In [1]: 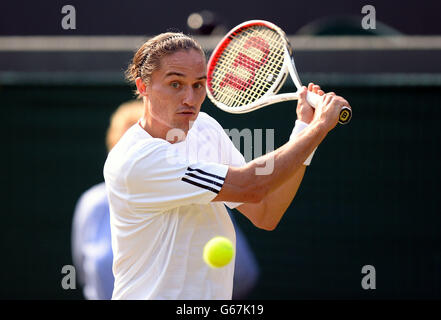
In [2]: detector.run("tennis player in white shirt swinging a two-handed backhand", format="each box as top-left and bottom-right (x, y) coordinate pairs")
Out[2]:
(104, 33), (349, 299)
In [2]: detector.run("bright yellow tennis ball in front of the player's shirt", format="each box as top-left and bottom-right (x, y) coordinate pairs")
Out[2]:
(203, 236), (234, 268)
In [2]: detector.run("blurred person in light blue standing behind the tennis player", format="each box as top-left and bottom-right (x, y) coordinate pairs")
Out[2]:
(72, 100), (259, 300)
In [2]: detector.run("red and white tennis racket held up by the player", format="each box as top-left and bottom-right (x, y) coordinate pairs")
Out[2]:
(207, 20), (352, 124)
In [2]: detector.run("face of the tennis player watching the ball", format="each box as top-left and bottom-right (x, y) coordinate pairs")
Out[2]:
(146, 49), (206, 139)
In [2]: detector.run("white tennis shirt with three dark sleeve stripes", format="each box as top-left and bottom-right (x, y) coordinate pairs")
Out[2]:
(104, 112), (245, 299)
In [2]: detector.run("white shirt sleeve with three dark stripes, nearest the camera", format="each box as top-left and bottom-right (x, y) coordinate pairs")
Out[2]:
(126, 142), (228, 212)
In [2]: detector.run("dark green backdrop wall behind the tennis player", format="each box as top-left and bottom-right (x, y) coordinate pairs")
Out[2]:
(0, 81), (441, 299)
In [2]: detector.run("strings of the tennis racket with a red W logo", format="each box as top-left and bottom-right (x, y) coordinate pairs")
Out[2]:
(211, 26), (284, 107)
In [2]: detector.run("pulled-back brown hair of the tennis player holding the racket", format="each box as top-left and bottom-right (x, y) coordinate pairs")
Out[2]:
(125, 32), (205, 95)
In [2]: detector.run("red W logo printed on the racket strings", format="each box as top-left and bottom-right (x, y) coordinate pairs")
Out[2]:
(219, 37), (269, 90)
